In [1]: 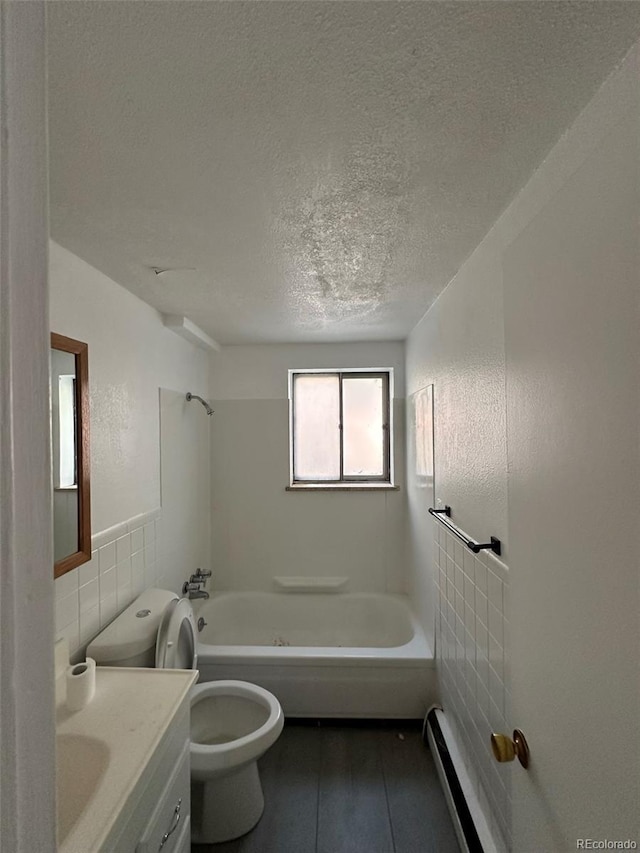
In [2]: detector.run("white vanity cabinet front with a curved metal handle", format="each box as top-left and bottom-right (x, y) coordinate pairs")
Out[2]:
(136, 743), (191, 853)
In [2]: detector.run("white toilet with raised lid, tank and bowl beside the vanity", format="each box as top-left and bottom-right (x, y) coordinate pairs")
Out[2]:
(87, 589), (284, 844)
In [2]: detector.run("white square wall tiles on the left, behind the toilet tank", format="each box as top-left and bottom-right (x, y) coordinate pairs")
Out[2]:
(55, 510), (161, 658)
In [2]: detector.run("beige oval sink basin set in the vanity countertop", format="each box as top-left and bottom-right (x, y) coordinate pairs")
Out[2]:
(56, 734), (109, 844)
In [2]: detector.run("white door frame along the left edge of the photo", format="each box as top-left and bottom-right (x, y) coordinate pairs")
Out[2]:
(0, 0), (55, 853)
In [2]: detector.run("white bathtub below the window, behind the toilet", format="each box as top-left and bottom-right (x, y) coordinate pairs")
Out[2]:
(193, 592), (435, 718)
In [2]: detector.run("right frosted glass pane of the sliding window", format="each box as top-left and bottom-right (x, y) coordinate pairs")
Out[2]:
(342, 376), (384, 477)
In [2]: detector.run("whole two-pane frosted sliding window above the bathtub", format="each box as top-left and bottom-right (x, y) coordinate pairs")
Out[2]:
(289, 370), (393, 487)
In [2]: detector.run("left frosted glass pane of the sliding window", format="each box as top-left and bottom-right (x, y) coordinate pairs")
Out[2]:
(293, 374), (340, 481)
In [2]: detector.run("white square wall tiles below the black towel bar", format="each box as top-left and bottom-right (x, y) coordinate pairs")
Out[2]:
(434, 521), (511, 850)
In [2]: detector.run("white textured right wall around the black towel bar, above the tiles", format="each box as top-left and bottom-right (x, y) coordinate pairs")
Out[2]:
(406, 236), (508, 648)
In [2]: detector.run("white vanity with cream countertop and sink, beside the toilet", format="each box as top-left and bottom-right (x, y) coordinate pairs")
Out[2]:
(56, 650), (197, 853)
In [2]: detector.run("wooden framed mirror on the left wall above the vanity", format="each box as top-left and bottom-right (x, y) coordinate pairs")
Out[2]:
(50, 333), (91, 578)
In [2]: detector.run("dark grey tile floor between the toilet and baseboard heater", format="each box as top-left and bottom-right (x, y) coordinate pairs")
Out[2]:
(192, 722), (458, 853)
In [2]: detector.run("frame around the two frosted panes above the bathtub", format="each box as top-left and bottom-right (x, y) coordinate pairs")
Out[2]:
(288, 367), (395, 489)
